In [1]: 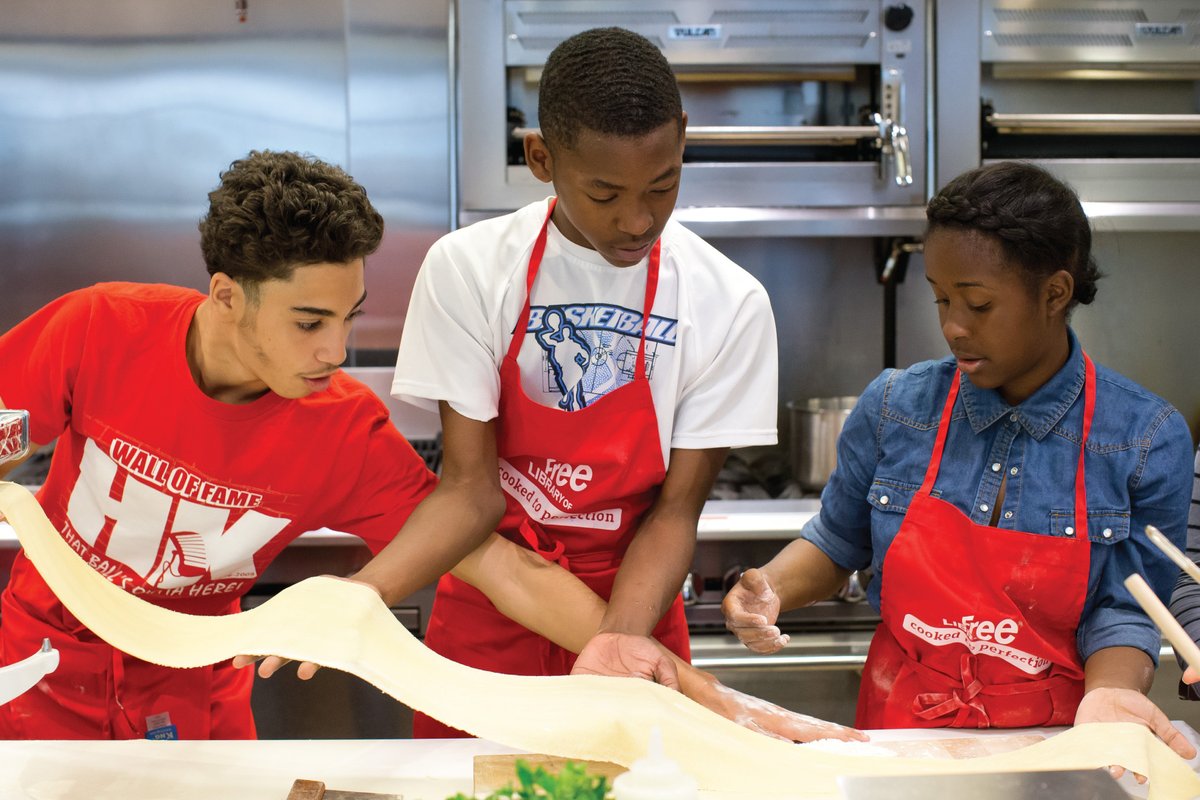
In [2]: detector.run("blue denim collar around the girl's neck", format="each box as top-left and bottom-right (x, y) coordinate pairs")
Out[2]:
(959, 327), (1085, 441)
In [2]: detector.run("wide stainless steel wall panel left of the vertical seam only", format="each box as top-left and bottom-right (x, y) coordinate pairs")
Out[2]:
(0, 0), (347, 330)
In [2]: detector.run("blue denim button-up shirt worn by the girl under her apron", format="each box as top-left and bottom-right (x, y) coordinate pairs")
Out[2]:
(800, 331), (1192, 664)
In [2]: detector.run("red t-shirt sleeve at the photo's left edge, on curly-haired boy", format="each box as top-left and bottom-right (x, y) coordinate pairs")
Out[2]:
(0, 289), (95, 445)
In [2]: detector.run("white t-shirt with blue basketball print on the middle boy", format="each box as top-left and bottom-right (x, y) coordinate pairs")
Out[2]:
(391, 200), (779, 462)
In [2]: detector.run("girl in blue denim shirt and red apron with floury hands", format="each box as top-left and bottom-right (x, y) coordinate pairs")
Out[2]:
(725, 162), (1195, 758)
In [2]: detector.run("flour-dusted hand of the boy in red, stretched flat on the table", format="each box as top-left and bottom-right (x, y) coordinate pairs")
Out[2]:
(684, 668), (868, 741)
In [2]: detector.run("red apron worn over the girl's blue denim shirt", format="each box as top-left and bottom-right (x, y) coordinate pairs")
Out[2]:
(854, 354), (1096, 729)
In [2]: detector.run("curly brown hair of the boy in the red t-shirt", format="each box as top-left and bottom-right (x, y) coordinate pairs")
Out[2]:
(199, 150), (383, 299)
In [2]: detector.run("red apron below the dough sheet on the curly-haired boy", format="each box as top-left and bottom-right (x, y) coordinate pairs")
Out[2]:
(0, 553), (254, 739)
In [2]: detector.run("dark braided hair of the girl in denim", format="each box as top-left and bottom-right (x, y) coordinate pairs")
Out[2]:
(925, 161), (1103, 309)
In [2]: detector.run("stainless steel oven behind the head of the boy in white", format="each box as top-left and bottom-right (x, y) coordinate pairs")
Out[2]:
(457, 0), (929, 235)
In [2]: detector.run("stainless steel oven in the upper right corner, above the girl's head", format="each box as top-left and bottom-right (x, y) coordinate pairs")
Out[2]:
(937, 0), (1200, 229)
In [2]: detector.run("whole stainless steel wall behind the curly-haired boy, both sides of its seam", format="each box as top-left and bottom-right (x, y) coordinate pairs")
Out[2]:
(0, 0), (450, 350)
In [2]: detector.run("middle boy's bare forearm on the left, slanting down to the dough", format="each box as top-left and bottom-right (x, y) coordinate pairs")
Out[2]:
(353, 481), (504, 604)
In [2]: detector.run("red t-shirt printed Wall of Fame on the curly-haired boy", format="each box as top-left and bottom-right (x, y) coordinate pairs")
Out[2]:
(0, 283), (436, 614)
